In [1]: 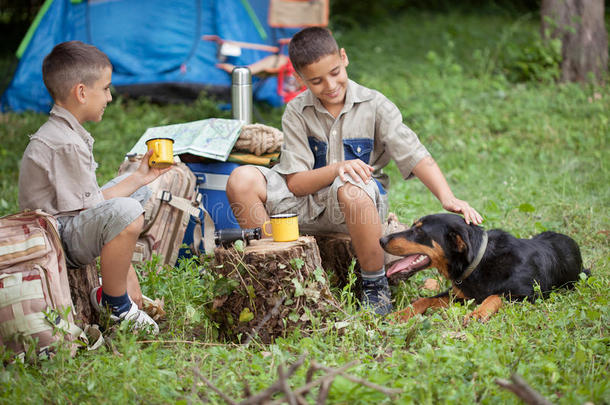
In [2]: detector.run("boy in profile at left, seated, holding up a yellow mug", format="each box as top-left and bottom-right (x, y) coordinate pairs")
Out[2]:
(19, 41), (169, 333)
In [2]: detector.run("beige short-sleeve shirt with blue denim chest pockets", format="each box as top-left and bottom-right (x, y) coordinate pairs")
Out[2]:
(273, 80), (430, 188)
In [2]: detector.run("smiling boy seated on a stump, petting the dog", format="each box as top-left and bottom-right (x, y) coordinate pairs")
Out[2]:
(227, 27), (482, 315)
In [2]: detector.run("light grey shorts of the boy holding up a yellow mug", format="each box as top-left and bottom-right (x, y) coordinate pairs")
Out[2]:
(57, 173), (151, 268)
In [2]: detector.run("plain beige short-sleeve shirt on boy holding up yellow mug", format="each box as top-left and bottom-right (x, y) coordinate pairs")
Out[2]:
(19, 105), (104, 216)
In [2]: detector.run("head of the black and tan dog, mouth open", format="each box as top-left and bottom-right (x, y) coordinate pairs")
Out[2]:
(379, 214), (480, 280)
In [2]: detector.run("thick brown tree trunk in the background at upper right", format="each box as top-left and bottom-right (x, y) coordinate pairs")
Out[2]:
(540, 0), (608, 84)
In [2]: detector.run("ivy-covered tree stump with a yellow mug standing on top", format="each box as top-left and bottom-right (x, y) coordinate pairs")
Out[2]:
(210, 236), (339, 343)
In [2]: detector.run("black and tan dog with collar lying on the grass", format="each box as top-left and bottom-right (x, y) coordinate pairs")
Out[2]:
(380, 214), (589, 323)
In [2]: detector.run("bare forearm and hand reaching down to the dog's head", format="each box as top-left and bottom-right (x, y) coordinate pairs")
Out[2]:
(413, 156), (483, 225)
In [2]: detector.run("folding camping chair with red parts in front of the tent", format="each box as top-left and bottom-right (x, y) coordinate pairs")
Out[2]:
(202, 0), (329, 103)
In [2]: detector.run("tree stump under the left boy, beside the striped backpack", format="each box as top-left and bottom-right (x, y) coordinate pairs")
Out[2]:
(68, 262), (100, 325)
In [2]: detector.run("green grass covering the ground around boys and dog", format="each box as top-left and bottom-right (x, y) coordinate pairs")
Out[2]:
(0, 13), (610, 404)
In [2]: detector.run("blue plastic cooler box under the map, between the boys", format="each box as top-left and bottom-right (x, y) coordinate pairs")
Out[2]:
(180, 162), (239, 256)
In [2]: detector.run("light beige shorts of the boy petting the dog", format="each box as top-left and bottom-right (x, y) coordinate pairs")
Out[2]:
(255, 166), (388, 234)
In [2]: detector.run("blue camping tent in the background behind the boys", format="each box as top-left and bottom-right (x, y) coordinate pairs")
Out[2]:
(1, 0), (295, 112)
